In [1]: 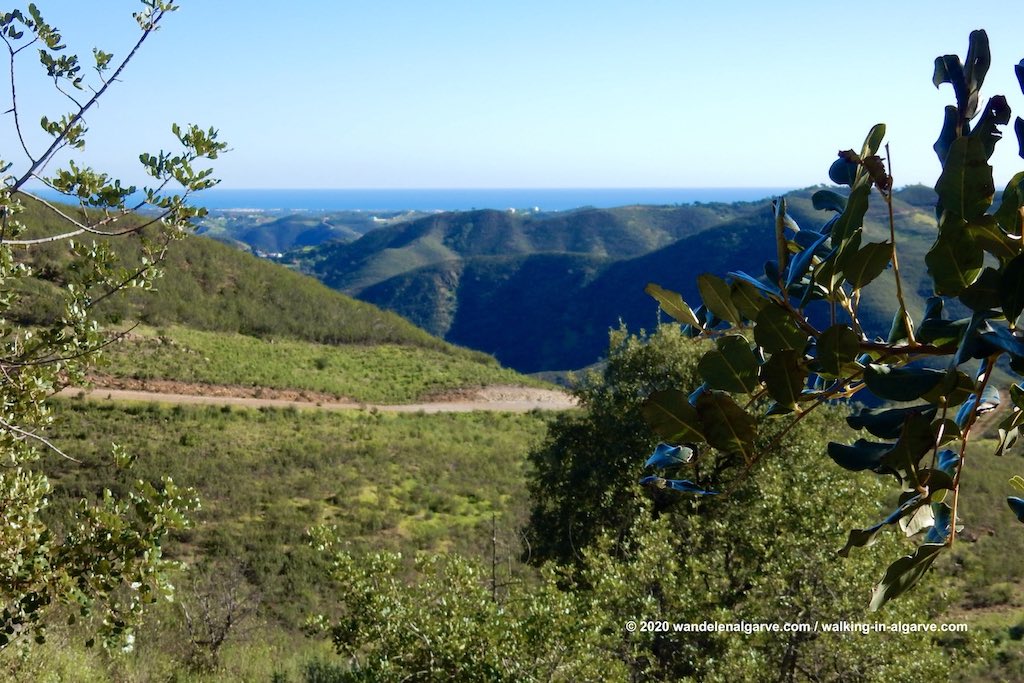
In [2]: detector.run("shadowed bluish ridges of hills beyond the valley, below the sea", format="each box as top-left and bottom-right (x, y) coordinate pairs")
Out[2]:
(284, 186), (935, 372)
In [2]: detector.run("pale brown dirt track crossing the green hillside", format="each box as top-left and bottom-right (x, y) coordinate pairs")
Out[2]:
(57, 385), (577, 413)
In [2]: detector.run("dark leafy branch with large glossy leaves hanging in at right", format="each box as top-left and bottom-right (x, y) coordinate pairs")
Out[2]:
(643, 31), (1024, 609)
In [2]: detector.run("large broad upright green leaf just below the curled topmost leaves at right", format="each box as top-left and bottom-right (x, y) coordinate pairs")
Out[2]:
(935, 137), (995, 219)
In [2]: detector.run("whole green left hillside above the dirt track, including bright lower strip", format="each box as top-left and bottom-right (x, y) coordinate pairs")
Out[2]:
(13, 193), (552, 403)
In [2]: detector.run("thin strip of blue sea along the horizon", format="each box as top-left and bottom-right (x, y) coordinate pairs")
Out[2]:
(169, 187), (791, 211)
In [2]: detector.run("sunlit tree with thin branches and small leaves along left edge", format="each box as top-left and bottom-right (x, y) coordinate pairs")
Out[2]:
(0, 0), (224, 648)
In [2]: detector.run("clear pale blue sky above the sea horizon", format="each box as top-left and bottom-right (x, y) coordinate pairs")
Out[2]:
(0, 0), (1024, 188)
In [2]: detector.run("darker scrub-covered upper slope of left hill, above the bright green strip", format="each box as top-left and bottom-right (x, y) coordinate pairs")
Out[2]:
(16, 192), (467, 354)
